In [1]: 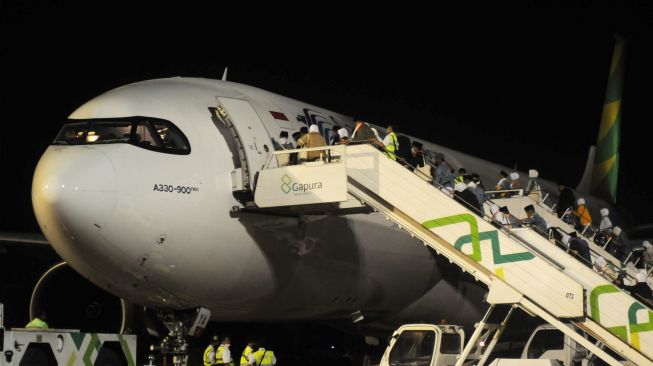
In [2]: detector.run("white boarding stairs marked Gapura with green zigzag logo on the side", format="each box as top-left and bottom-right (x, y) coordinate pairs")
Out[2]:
(255, 145), (653, 366)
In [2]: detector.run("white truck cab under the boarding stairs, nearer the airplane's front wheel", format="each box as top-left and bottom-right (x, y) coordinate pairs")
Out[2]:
(380, 324), (465, 366)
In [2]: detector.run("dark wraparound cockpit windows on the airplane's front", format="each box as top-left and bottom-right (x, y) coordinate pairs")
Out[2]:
(53, 117), (190, 154)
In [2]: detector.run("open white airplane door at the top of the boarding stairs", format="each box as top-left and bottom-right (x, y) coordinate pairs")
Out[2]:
(217, 97), (274, 190)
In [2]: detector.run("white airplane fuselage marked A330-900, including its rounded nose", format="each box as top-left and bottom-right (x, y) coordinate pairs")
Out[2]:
(32, 78), (483, 321)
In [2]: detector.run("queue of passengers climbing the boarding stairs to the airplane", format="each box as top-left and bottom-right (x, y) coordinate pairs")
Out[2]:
(268, 121), (653, 302)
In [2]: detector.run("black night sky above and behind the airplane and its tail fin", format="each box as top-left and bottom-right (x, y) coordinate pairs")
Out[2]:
(0, 1), (653, 231)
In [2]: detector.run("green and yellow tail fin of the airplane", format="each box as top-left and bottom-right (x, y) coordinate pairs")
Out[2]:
(579, 36), (625, 203)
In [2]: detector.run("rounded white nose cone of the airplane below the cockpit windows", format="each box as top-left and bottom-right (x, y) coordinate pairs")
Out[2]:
(32, 146), (118, 244)
